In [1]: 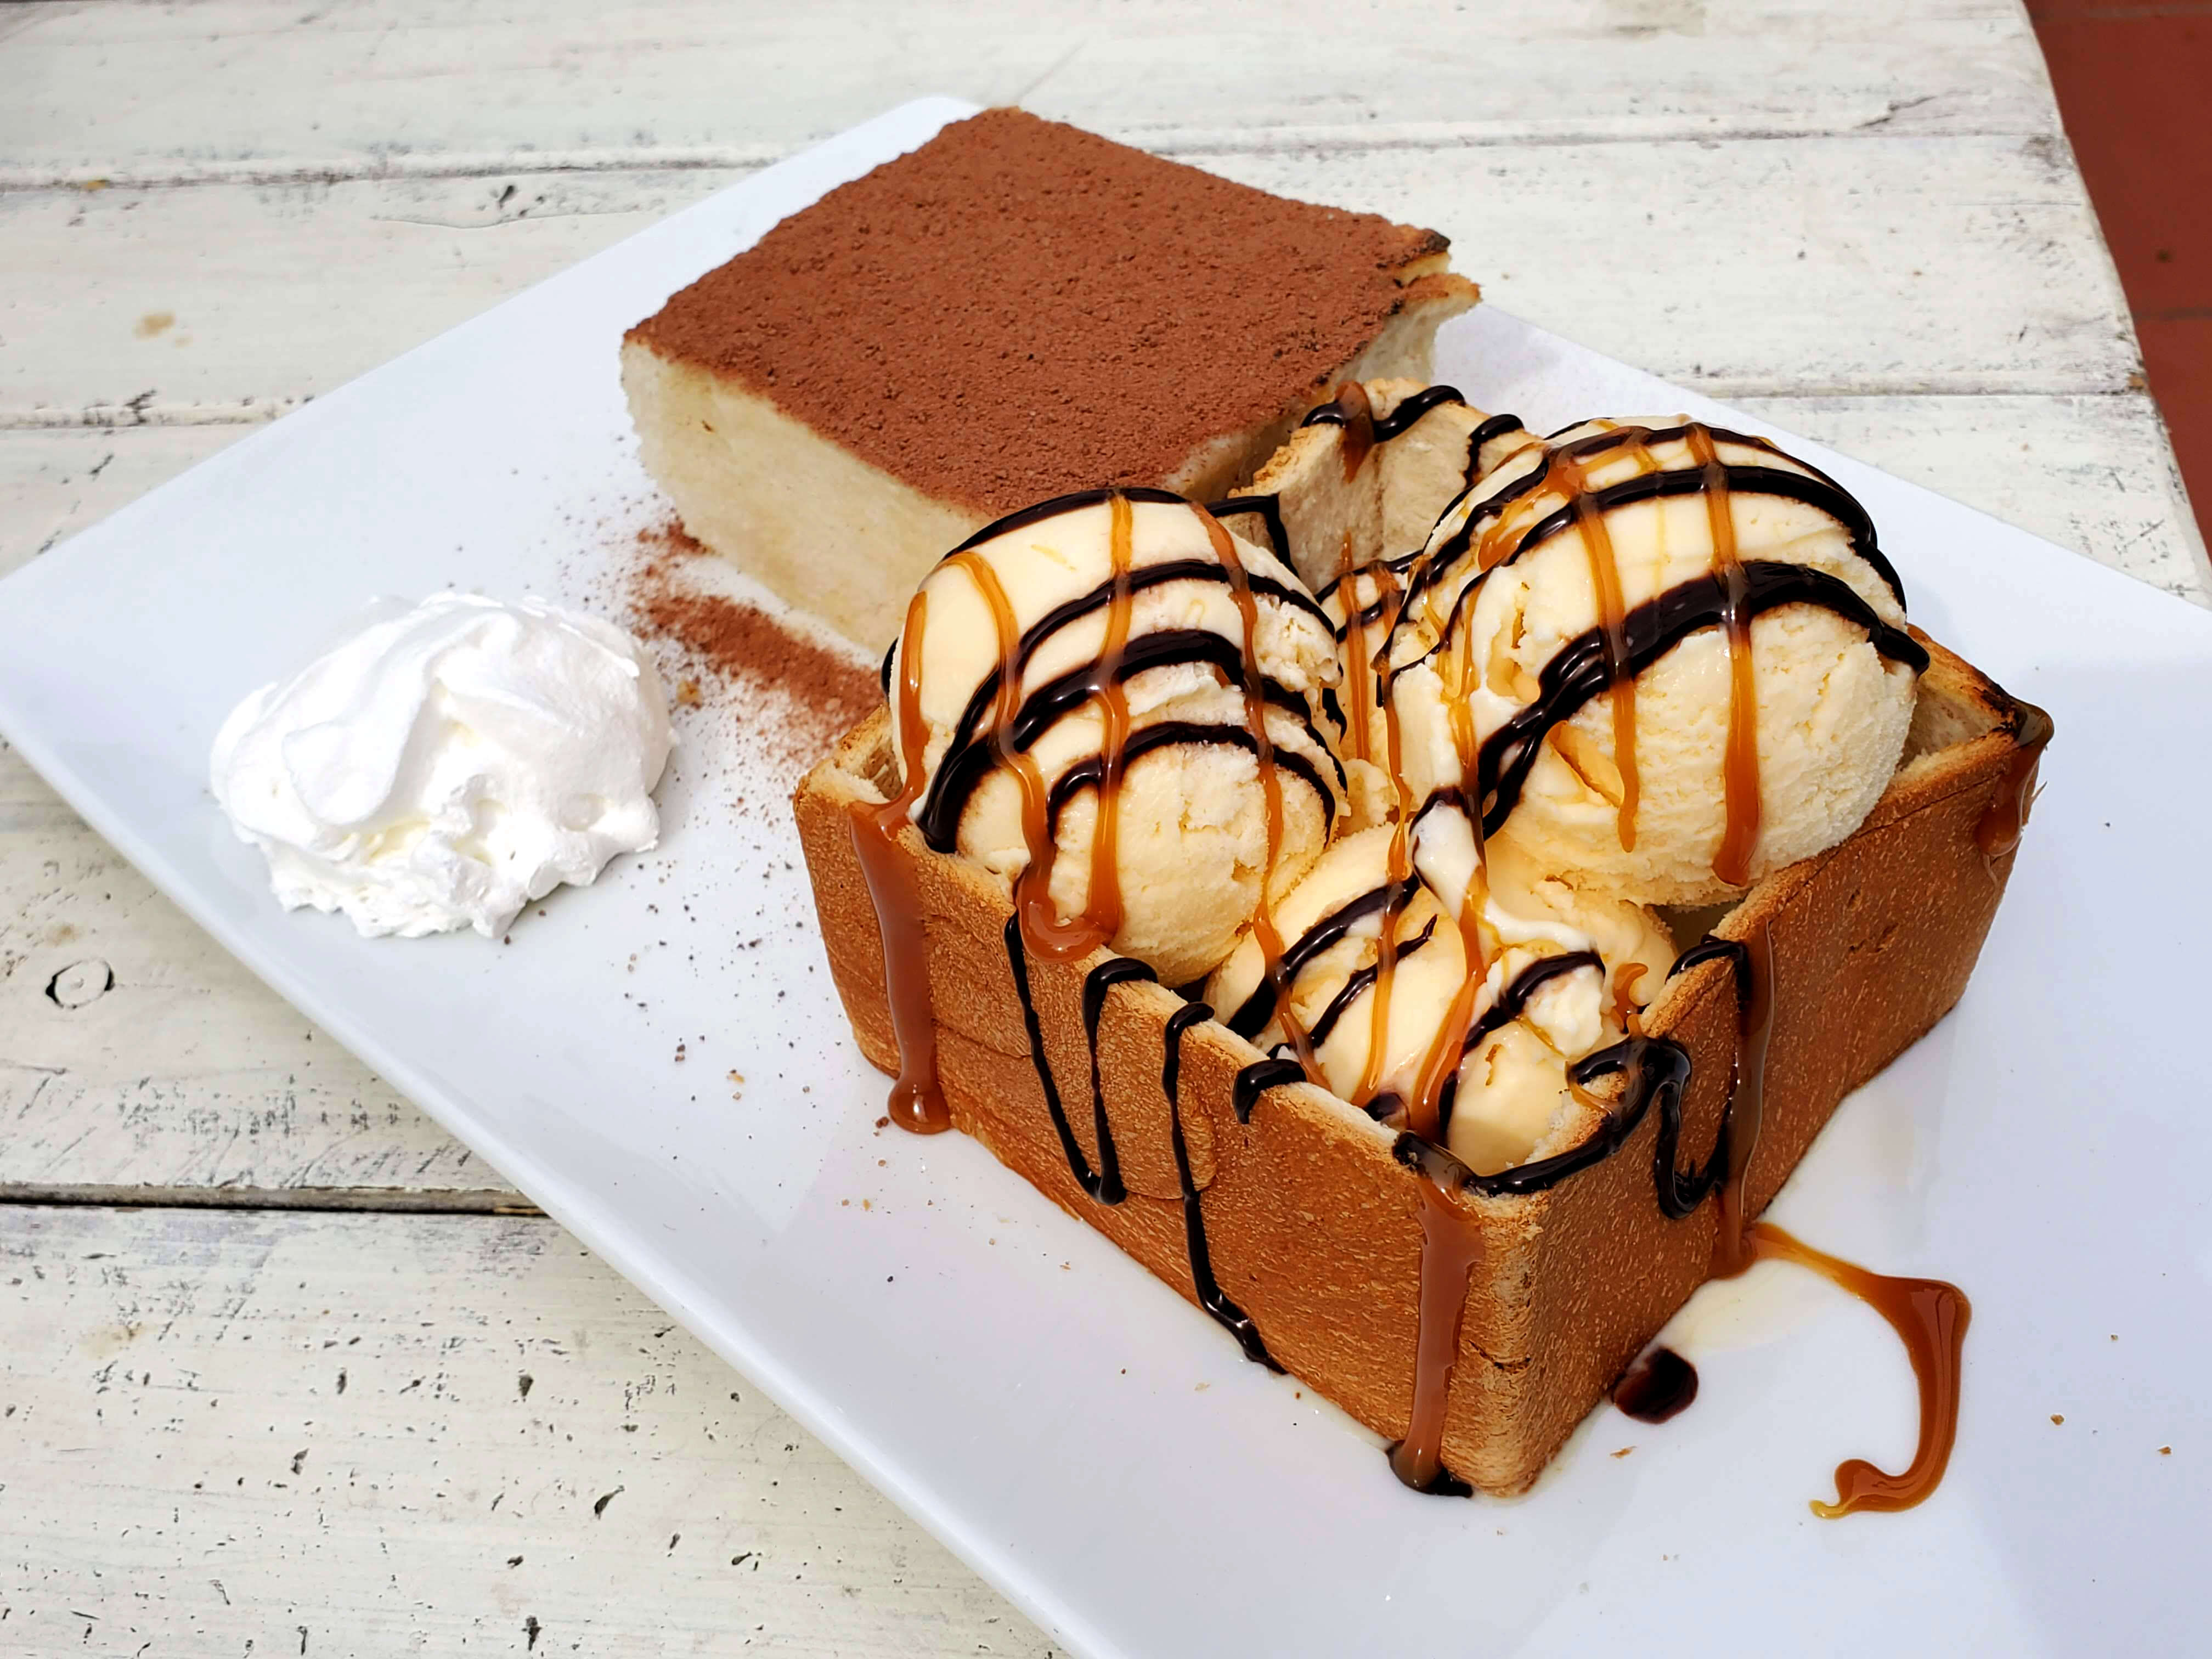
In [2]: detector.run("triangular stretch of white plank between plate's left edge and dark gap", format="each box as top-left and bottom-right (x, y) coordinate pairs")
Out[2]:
(0, 746), (527, 1207)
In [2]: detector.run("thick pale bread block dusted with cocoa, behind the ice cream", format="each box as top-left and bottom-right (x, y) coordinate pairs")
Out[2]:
(622, 109), (1475, 650)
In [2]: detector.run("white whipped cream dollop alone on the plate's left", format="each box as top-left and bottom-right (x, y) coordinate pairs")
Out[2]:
(210, 593), (673, 938)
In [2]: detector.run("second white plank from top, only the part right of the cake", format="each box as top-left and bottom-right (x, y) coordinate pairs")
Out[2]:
(1194, 137), (2141, 398)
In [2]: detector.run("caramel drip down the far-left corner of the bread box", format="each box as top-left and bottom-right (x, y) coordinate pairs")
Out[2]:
(851, 593), (953, 1135)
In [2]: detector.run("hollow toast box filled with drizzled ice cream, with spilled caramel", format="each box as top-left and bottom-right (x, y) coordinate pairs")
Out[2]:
(797, 381), (2049, 1513)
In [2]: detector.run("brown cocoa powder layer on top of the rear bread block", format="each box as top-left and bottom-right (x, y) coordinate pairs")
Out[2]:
(630, 109), (1447, 515)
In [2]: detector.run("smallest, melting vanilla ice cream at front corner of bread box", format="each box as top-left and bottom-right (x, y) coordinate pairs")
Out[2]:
(1205, 825), (1674, 1175)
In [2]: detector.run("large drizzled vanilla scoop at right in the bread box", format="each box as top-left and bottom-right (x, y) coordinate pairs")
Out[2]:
(1376, 418), (1927, 905)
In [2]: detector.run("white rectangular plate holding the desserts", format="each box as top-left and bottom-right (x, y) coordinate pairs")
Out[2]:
(0, 99), (2212, 1657)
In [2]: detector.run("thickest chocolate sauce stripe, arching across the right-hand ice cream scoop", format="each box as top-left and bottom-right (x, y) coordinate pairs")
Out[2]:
(1460, 562), (1929, 836)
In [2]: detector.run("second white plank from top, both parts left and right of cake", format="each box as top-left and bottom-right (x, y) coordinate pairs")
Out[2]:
(0, 137), (2139, 427)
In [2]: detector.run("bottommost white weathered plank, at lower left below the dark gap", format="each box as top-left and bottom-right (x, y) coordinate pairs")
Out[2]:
(0, 1205), (1053, 1659)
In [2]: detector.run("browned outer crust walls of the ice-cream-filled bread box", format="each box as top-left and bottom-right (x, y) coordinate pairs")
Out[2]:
(794, 630), (2026, 1493)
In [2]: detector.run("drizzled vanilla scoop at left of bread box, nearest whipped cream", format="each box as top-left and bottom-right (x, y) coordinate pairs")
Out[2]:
(887, 489), (1345, 984)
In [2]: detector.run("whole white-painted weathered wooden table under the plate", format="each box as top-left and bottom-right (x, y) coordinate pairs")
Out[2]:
(0, 0), (2212, 1655)
